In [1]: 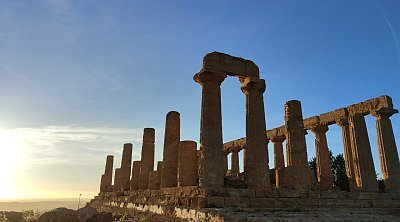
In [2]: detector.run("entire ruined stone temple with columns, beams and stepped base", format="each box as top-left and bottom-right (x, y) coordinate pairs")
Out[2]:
(90, 52), (400, 221)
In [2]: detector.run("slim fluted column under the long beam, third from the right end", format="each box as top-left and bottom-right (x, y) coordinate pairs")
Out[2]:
(336, 118), (357, 191)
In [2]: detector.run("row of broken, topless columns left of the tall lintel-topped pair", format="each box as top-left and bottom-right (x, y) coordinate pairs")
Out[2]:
(100, 111), (198, 192)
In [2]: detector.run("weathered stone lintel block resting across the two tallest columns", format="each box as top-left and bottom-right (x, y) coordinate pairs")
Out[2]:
(201, 52), (259, 78)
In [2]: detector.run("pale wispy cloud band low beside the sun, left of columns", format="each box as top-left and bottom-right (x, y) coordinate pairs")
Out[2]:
(0, 126), (142, 166)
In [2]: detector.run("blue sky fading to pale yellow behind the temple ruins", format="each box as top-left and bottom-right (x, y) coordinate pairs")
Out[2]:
(0, 0), (400, 200)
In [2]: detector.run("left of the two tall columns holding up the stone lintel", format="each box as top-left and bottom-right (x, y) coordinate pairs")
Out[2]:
(194, 71), (228, 187)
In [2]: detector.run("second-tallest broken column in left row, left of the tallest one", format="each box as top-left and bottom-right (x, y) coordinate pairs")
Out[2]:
(139, 128), (155, 190)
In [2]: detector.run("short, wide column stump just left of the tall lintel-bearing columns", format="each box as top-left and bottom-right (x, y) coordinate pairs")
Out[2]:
(178, 141), (198, 187)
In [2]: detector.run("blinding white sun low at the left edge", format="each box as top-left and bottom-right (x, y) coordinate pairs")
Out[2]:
(0, 129), (22, 199)
